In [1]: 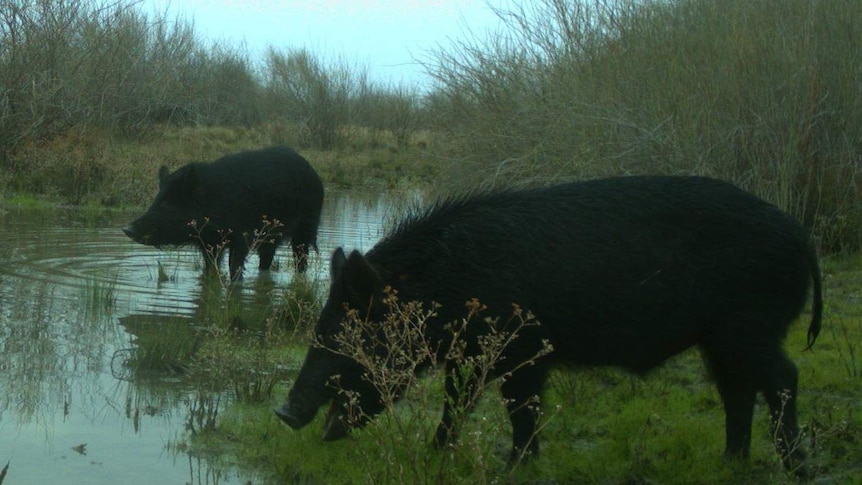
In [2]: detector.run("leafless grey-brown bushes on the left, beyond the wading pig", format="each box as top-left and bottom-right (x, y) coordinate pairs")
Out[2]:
(0, 0), (416, 153)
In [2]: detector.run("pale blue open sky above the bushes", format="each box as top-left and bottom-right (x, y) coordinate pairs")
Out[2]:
(145, 0), (508, 85)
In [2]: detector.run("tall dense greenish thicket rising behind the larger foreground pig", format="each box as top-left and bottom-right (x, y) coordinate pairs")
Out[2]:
(427, 0), (862, 250)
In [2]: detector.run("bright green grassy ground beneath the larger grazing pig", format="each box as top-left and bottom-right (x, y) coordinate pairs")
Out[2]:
(182, 257), (862, 484)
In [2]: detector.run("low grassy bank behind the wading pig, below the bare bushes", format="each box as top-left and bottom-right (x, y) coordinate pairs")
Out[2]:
(0, 125), (440, 207)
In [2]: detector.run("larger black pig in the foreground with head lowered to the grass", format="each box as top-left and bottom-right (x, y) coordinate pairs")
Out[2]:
(276, 176), (823, 469)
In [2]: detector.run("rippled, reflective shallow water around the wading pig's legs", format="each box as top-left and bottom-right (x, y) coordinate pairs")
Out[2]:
(0, 190), (412, 485)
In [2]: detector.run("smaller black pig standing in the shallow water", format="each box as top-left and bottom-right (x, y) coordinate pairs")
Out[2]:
(123, 147), (323, 279)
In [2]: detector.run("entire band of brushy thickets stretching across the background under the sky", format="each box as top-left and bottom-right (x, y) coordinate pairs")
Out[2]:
(0, 0), (862, 250)
